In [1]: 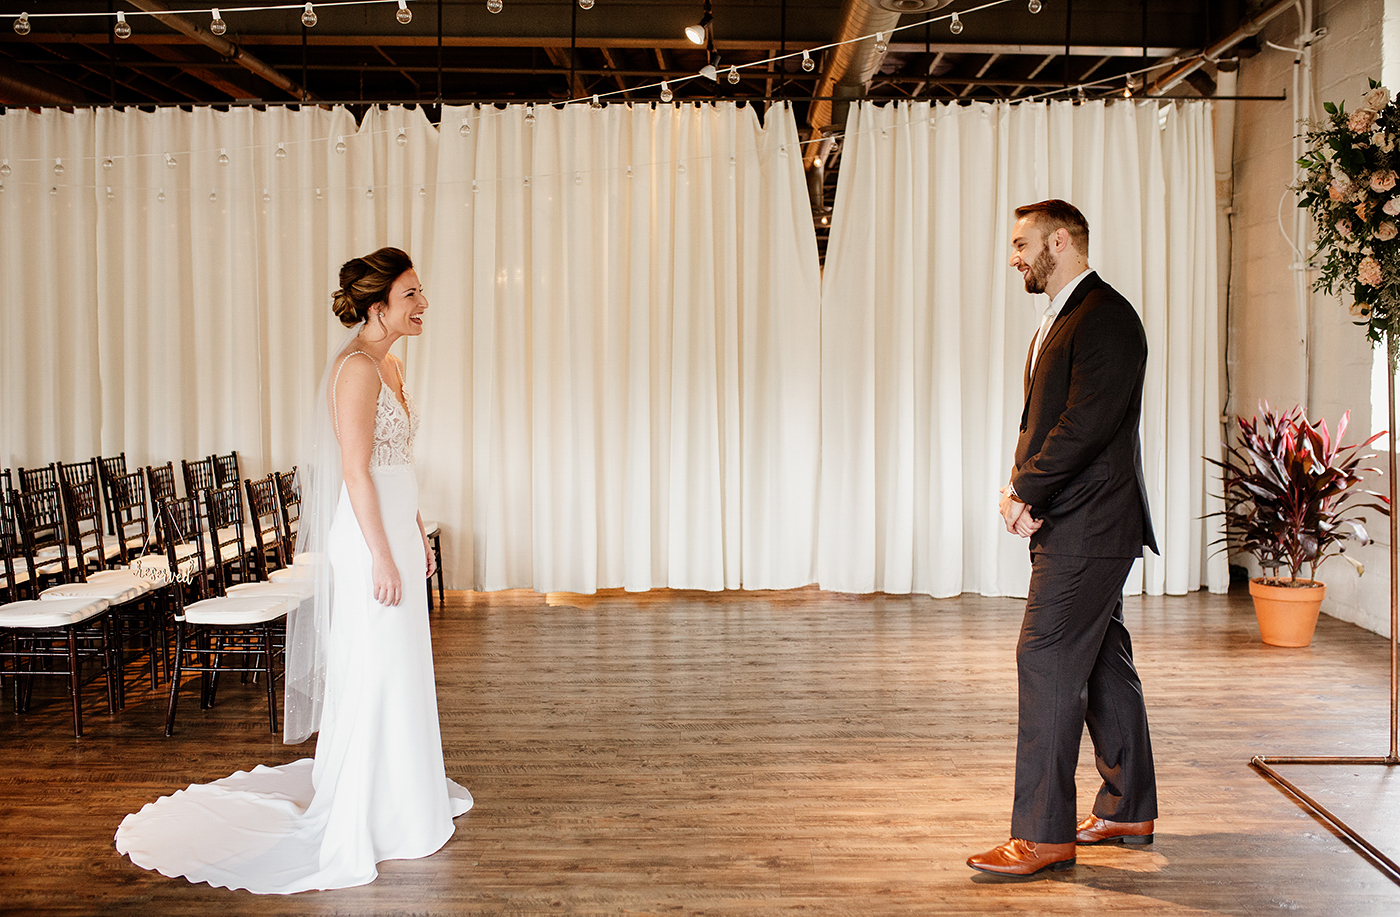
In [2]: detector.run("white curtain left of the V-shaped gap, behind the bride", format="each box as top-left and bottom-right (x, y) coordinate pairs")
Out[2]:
(0, 105), (820, 591)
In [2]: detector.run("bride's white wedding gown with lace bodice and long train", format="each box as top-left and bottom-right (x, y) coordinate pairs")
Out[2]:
(116, 361), (472, 895)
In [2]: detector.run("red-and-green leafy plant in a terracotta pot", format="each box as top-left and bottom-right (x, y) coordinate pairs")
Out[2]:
(1207, 403), (1390, 647)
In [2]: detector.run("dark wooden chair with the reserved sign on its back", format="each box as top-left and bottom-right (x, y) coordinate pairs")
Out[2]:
(164, 497), (288, 735)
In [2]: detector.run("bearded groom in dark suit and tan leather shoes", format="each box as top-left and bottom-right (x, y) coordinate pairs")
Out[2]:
(967, 200), (1156, 875)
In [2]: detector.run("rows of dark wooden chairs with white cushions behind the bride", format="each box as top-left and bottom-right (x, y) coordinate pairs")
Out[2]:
(0, 454), (305, 735)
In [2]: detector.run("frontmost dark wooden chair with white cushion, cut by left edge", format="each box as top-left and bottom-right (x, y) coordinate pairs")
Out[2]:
(0, 480), (119, 738)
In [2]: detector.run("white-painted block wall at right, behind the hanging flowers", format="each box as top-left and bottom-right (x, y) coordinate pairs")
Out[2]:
(1226, 0), (1400, 634)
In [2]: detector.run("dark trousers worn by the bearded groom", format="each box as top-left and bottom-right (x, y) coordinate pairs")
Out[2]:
(1011, 552), (1156, 844)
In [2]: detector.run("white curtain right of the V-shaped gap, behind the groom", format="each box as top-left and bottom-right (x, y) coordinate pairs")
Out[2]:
(818, 102), (1228, 596)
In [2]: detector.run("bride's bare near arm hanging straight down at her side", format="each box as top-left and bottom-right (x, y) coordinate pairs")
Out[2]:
(335, 356), (403, 605)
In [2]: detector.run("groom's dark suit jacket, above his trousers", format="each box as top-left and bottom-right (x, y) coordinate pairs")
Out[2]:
(1011, 273), (1159, 557)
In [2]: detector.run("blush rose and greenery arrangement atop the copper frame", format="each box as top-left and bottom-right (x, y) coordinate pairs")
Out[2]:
(1292, 80), (1400, 343)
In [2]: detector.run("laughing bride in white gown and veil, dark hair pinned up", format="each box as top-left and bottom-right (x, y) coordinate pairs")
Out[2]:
(116, 248), (472, 895)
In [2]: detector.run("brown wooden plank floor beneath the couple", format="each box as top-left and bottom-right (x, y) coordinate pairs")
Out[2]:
(0, 589), (1400, 917)
